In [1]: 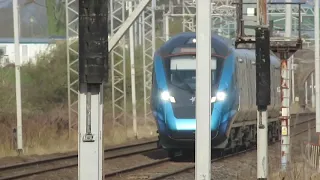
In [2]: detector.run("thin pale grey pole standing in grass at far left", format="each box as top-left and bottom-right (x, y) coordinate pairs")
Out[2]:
(13, 0), (23, 154)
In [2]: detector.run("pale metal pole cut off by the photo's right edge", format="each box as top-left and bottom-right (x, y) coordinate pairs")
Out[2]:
(314, 1), (320, 133)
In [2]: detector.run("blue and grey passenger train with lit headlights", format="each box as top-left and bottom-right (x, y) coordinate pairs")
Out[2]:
(151, 32), (281, 156)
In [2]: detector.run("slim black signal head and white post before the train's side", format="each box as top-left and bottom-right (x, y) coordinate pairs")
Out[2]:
(256, 27), (271, 179)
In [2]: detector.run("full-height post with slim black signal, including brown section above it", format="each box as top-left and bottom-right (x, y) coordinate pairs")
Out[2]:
(256, 0), (271, 180)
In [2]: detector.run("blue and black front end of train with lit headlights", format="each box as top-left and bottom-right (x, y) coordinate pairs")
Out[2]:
(151, 37), (232, 150)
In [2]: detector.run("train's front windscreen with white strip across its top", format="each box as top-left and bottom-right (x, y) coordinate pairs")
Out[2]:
(169, 56), (217, 91)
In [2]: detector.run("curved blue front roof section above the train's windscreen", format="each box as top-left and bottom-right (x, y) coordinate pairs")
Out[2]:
(156, 32), (232, 57)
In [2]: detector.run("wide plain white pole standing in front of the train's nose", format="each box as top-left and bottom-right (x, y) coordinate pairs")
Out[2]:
(195, 1), (211, 180)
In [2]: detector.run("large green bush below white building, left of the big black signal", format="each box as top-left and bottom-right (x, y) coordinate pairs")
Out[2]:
(0, 45), (68, 114)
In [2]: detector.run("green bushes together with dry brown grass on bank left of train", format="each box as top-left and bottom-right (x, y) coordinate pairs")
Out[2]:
(0, 17), (182, 157)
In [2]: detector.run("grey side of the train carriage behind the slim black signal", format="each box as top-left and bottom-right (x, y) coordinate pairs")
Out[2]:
(229, 49), (281, 122)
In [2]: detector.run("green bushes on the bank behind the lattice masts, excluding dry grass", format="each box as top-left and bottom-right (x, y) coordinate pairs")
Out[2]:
(0, 18), (182, 115)
